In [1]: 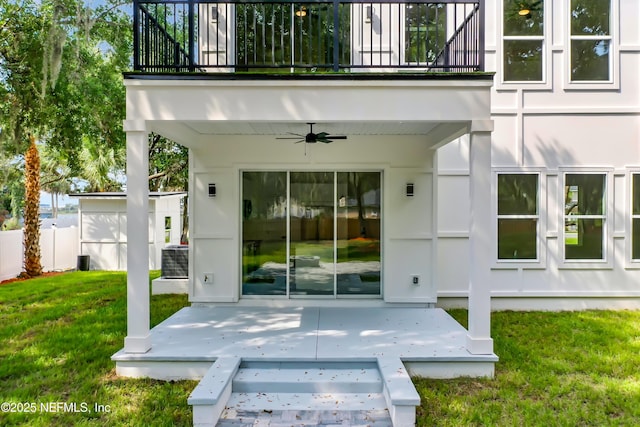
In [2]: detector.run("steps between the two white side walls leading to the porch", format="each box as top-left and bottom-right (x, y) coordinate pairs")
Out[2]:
(217, 361), (392, 427)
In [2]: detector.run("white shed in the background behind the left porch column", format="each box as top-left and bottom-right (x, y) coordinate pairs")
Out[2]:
(70, 192), (186, 271)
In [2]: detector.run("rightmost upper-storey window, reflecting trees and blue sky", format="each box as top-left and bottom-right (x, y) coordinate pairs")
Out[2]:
(570, 0), (612, 82)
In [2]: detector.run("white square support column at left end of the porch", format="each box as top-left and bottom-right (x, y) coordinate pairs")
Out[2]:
(124, 120), (151, 353)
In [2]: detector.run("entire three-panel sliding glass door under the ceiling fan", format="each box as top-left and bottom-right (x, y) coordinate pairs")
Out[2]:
(242, 171), (382, 298)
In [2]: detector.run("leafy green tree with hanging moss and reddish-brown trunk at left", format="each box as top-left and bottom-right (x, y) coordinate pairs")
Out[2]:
(0, 0), (130, 275)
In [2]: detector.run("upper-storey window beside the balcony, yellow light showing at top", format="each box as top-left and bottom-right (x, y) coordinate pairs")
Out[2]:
(502, 0), (544, 82)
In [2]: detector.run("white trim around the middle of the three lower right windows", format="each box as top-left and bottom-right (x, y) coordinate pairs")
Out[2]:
(558, 167), (614, 270)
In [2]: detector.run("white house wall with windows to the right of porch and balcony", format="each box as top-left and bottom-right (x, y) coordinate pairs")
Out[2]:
(438, 0), (640, 309)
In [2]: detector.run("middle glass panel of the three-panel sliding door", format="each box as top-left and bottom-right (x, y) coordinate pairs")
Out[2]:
(289, 172), (335, 296)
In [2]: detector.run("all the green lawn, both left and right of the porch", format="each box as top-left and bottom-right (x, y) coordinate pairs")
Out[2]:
(0, 272), (640, 426)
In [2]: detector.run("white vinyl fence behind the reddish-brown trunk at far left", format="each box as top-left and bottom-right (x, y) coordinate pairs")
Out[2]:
(0, 227), (78, 280)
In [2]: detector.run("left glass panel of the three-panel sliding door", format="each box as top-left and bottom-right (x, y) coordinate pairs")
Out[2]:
(242, 172), (287, 295)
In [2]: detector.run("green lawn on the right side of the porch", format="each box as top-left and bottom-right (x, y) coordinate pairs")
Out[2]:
(415, 311), (640, 426)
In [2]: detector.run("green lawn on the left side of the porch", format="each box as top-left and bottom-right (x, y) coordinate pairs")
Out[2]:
(0, 272), (196, 426)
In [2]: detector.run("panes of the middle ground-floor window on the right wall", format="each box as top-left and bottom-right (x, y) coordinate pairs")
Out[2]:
(564, 173), (606, 260)
